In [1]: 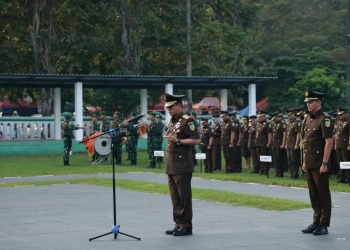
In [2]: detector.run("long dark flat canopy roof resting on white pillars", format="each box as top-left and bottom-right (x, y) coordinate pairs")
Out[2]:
(0, 73), (277, 89)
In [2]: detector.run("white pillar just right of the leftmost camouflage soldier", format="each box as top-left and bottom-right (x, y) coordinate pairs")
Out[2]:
(74, 82), (83, 141)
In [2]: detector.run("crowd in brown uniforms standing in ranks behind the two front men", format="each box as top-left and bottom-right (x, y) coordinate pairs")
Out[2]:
(199, 102), (350, 183)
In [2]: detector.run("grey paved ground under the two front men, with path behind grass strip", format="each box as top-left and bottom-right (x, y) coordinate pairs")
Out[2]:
(0, 173), (350, 250)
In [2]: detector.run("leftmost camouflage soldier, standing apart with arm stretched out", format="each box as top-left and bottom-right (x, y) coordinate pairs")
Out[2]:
(61, 112), (80, 166)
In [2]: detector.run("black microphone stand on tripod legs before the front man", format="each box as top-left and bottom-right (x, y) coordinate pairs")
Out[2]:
(80, 124), (141, 241)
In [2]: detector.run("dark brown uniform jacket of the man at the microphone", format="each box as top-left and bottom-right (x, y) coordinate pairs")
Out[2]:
(165, 113), (200, 175)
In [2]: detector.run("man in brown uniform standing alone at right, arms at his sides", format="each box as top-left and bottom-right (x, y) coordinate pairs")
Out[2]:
(301, 91), (333, 235)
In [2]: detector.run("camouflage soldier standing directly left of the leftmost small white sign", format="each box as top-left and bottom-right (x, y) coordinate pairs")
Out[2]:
(147, 112), (159, 168)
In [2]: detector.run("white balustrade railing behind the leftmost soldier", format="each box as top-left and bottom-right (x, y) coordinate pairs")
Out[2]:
(0, 117), (90, 141)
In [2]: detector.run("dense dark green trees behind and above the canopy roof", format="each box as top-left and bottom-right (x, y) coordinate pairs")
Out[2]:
(0, 0), (347, 114)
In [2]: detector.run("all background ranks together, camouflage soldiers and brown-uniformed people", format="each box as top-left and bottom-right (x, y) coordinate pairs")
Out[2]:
(62, 96), (350, 183)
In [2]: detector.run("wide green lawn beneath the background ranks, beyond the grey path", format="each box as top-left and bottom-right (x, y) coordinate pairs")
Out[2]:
(0, 152), (350, 192)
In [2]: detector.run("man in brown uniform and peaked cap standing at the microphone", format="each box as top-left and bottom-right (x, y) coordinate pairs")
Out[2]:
(165, 93), (200, 236)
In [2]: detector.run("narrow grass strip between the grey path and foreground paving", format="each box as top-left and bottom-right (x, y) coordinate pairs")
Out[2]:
(0, 178), (310, 211)
